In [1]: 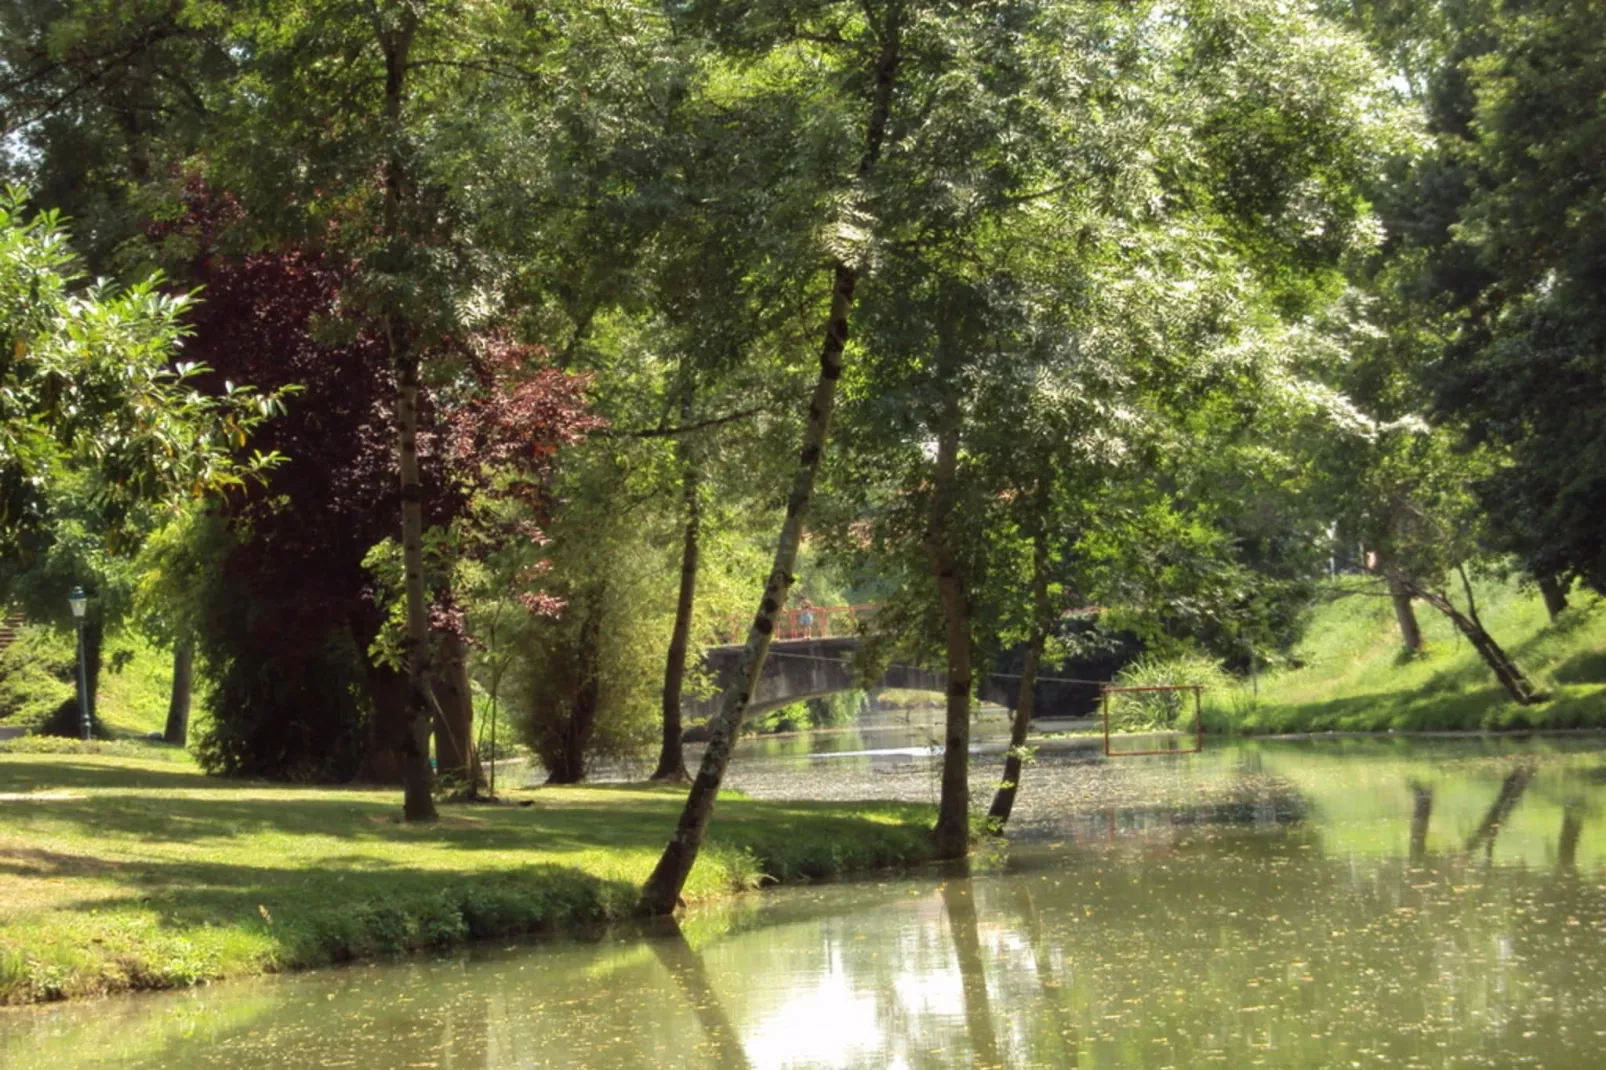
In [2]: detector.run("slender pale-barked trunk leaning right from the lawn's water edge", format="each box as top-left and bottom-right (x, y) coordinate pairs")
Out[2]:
(638, 18), (901, 914)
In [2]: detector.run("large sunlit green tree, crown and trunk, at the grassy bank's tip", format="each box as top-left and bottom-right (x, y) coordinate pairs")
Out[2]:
(822, 5), (1400, 855)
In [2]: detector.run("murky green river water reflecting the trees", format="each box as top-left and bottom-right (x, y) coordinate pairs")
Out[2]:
(0, 731), (1606, 1070)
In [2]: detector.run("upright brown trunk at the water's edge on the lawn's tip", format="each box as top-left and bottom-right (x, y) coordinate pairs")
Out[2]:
(925, 406), (972, 858)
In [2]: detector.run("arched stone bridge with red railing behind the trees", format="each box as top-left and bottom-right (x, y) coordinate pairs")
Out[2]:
(683, 636), (1099, 720)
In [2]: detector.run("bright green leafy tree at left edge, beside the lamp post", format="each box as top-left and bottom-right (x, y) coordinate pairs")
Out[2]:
(0, 190), (283, 729)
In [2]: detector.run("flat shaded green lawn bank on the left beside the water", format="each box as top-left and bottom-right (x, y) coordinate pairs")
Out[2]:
(0, 744), (933, 1004)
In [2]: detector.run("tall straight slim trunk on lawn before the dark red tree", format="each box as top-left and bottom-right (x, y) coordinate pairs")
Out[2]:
(374, 8), (437, 821)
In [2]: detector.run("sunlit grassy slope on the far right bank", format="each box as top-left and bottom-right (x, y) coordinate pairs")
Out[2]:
(1209, 582), (1606, 733)
